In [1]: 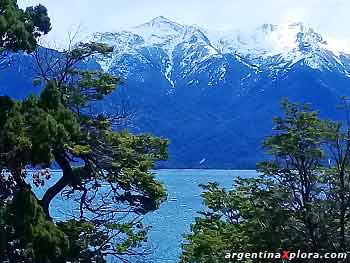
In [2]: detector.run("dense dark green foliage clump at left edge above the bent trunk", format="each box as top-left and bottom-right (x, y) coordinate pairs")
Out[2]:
(0, 83), (82, 170)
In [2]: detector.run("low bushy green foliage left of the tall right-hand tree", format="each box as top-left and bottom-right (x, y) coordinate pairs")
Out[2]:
(181, 177), (296, 263)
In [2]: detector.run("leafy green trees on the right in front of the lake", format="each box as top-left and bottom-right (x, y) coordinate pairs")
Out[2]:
(181, 100), (350, 263)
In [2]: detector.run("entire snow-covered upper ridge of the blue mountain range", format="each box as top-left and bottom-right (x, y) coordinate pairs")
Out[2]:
(94, 17), (349, 83)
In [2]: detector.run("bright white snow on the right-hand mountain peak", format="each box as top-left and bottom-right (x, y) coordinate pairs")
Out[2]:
(209, 23), (348, 69)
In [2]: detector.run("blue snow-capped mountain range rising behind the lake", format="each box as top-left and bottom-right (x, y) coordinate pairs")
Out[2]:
(0, 17), (350, 168)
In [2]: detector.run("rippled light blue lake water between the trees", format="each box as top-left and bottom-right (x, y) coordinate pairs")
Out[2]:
(33, 170), (256, 263)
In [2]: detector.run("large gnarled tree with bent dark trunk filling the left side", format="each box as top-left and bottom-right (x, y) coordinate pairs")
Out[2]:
(0, 4), (167, 263)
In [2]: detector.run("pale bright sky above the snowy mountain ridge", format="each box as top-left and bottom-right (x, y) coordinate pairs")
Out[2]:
(18, 0), (350, 47)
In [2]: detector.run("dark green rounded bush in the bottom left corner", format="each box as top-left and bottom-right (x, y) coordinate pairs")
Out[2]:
(0, 189), (68, 263)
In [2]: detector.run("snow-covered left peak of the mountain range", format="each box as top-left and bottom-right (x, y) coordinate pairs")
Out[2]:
(94, 17), (223, 87)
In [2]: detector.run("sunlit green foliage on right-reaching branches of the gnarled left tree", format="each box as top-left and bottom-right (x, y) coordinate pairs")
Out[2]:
(100, 131), (167, 213)
